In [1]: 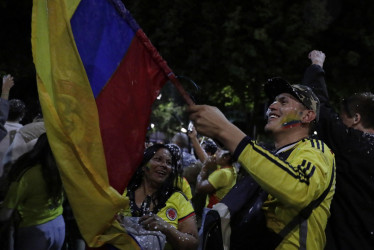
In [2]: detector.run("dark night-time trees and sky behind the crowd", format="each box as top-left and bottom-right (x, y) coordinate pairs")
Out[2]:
(0, 0), (374, 137)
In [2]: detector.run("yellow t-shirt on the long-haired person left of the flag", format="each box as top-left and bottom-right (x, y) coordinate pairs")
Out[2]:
(3, 165), (63, 227)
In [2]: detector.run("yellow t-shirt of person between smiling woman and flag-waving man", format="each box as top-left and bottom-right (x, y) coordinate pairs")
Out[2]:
(206, 166), (236, 208)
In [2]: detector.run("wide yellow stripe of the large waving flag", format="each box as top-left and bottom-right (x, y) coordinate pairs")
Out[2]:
(31, 0), (139, 249)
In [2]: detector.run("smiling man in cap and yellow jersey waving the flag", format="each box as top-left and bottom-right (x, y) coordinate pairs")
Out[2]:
(188, 78), (335, 250)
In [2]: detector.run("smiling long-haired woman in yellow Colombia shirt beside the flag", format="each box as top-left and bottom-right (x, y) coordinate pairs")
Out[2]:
(123, 144), (198, 249)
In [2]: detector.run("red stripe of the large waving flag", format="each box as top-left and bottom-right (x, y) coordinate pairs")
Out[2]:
(96, 34), (167, 193)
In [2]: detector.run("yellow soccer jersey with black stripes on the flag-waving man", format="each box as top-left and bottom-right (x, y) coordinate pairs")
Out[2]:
(234, 137), (335, 250)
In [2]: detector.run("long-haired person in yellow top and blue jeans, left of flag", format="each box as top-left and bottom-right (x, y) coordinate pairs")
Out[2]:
(0, 134), (65, 250)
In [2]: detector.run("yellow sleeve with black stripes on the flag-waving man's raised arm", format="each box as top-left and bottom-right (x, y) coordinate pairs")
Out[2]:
(235, 137), (335, 208)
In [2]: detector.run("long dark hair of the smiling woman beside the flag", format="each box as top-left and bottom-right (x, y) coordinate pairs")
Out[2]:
(127, 144), (182, 213)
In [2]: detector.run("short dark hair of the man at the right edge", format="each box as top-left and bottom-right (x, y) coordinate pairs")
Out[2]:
(341, 92), (374, 128)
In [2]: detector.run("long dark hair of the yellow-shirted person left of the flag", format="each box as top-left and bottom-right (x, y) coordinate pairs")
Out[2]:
(8, 133), (62, 206)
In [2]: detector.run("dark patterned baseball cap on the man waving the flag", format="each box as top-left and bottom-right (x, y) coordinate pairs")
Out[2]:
(265, 77), (320, 121)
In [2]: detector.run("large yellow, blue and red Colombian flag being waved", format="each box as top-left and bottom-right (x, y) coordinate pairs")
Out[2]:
(31, 0), (175, 249)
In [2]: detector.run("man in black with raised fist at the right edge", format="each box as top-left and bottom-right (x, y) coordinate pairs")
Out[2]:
(303, 50), (374, 250)
